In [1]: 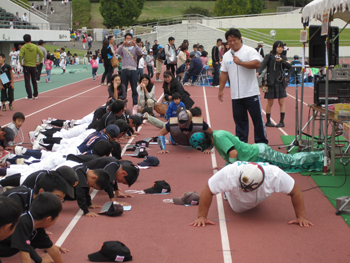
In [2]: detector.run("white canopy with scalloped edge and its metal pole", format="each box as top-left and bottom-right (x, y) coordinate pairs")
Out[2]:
(302, 0), (350, 175)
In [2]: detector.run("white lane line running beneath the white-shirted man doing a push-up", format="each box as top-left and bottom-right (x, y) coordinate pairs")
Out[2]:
(203, 86), (232, 263)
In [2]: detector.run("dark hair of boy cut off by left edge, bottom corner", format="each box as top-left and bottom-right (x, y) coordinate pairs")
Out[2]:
(0, 196), (22, 230)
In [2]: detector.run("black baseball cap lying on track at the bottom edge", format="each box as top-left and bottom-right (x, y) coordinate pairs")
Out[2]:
(88, 241), (132, 262)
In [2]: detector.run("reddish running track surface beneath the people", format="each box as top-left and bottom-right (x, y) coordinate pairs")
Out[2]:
(1, 64), (350, 263)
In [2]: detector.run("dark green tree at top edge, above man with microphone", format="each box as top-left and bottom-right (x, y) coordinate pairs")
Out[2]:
(214, 0), (251, 16)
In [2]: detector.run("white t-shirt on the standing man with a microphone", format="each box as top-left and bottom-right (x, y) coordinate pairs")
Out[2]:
(221, 45), (262, 99)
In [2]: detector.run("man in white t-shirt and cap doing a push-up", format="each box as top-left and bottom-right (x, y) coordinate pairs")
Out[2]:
(190, 162), (313, 227)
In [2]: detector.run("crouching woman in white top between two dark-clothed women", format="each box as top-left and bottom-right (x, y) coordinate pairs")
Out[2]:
(136, 74), (157, 110)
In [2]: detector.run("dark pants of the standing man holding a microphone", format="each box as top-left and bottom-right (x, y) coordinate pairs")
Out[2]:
(232, 95), (268, 144)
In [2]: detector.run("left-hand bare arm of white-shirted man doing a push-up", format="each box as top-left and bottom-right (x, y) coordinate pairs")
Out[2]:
(189, 184), (214, 226)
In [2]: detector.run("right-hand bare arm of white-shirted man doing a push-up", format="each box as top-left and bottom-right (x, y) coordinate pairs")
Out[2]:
(288, 184), (314, 227)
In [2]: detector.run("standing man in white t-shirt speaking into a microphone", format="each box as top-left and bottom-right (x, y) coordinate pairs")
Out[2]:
(218, 28), (268, 144)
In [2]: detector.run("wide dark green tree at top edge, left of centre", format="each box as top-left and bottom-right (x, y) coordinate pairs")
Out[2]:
(99, 0), (146, 28)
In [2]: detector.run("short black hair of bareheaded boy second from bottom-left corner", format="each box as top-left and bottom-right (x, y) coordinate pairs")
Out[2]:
(30, 193), (63, 220)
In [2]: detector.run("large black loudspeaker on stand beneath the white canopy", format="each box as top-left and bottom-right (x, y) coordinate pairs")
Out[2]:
(309, 26), (339, 67)
